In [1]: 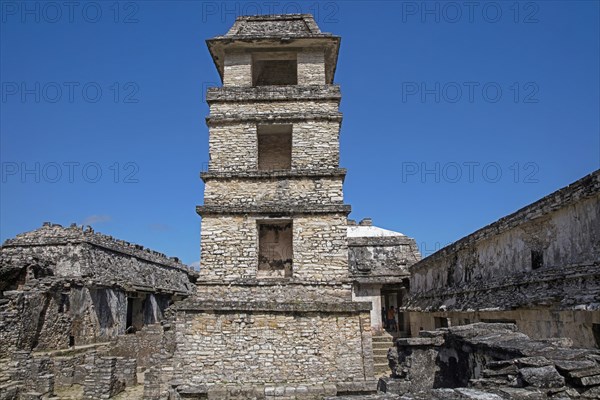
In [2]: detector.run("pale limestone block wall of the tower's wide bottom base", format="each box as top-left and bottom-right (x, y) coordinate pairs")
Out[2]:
(173, 311), (372, 385)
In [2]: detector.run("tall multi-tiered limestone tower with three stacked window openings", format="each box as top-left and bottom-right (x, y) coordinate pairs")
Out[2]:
(148, 15), (373, 397)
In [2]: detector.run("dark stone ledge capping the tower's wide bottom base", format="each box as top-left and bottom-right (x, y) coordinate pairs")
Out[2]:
(173, 298), (371, 313)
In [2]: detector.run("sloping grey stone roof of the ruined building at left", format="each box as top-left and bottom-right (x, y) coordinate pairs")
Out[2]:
(2, 223), (195, 293)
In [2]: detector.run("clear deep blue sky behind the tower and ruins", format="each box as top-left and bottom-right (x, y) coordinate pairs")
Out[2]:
(0, 0), (600, 263)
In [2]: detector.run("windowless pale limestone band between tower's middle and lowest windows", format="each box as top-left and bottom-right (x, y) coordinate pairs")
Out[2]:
(204, 177), (344, 206)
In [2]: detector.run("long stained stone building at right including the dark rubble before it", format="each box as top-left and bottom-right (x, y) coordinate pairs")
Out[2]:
(379, 170), (600, 400)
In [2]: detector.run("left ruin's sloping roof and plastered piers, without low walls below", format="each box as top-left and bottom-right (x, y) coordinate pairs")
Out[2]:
(0, 224), (196, 358)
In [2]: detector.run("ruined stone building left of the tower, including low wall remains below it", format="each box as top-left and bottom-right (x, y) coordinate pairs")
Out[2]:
(0, 223), (197, 399)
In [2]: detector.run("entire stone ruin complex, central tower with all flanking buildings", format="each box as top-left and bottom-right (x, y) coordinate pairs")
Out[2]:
(0, 15), (600, 400)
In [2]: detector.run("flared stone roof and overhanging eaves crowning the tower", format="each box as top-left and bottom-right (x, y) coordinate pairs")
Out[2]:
(206, 14), (341, 84)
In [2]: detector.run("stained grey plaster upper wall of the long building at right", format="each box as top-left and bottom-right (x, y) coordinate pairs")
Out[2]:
(411, 174), (600, 293)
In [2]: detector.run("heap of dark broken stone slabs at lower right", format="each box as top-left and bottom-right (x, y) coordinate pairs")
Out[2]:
(380, 323), (600, 399)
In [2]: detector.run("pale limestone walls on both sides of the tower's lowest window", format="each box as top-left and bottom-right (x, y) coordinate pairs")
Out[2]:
(200, 214), (348, 282)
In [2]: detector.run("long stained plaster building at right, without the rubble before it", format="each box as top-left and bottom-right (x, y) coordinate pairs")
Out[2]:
(408, 171), (600, 347)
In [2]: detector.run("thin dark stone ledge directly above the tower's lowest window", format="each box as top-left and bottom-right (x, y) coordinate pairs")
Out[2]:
(196, 204), (352, 216)
